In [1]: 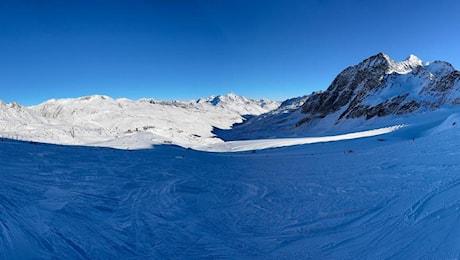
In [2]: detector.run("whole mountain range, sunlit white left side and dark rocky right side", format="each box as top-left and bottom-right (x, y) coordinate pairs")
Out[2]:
(0, 53), (460, 149)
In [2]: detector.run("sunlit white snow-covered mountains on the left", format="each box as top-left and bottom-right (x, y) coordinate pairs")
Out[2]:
(0, 94), (279, 149)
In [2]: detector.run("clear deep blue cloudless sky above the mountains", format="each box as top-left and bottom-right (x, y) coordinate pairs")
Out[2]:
(0, 0), (460, 105)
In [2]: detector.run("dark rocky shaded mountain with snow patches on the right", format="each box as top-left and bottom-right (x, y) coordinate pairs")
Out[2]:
(225, 53), (460, 140)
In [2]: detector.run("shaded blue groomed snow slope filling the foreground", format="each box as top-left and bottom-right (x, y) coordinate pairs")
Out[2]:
(0, 108), (460, 259)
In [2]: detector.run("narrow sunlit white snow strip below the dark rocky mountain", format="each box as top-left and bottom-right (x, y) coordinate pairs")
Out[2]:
(199, 125), (406, 152)
